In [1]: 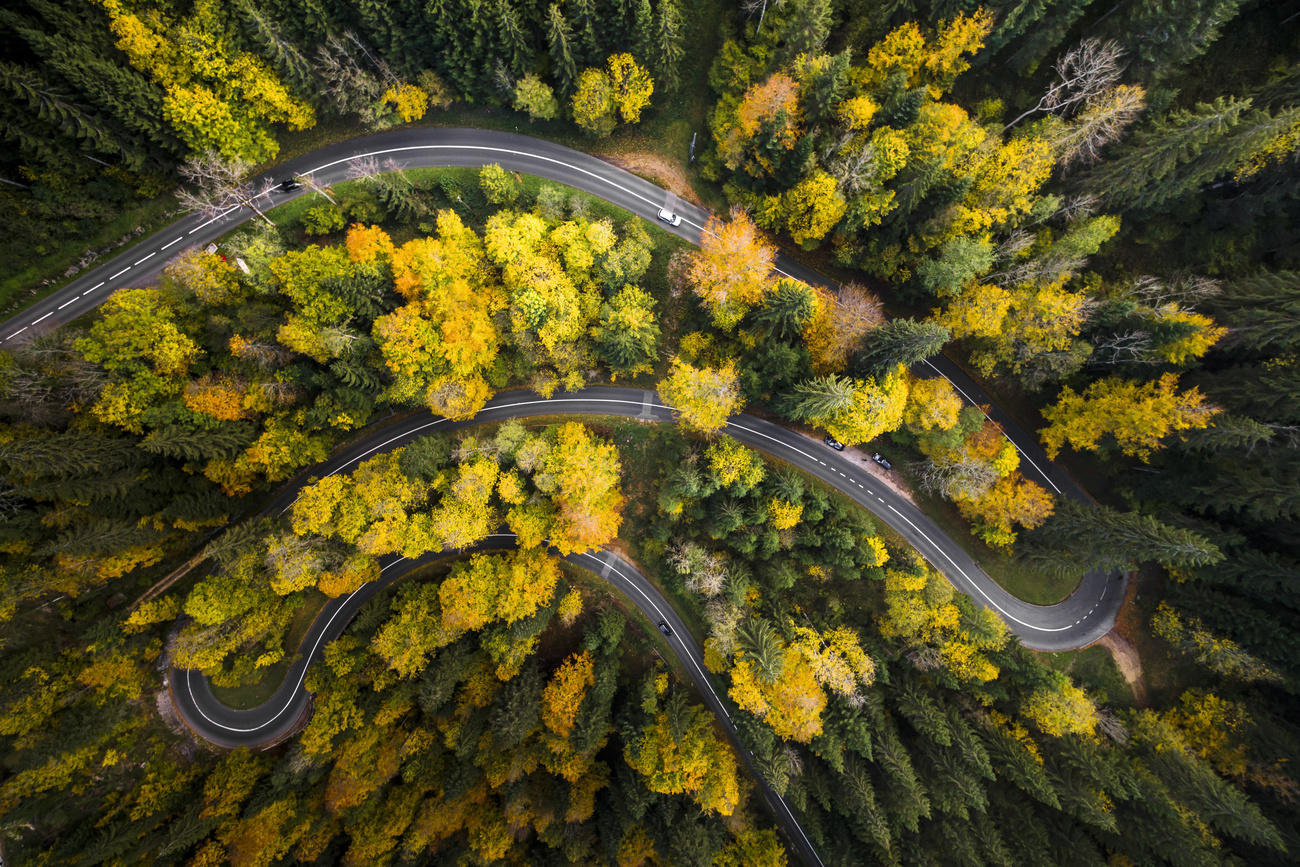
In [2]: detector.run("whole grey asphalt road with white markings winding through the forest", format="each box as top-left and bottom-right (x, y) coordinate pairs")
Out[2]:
(0, 129), (1125, 863)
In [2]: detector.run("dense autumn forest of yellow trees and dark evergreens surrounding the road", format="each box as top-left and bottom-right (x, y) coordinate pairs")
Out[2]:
(0, 0), (1300, 867)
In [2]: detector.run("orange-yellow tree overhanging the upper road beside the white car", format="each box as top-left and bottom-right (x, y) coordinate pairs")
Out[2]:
(686, 209), (776, 330)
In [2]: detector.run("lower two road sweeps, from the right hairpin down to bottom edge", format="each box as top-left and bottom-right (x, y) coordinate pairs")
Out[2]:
(168, 387), (1122, 866)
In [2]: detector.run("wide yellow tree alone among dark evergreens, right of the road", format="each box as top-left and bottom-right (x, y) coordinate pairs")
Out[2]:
(1039, 373), (1219, 460)
